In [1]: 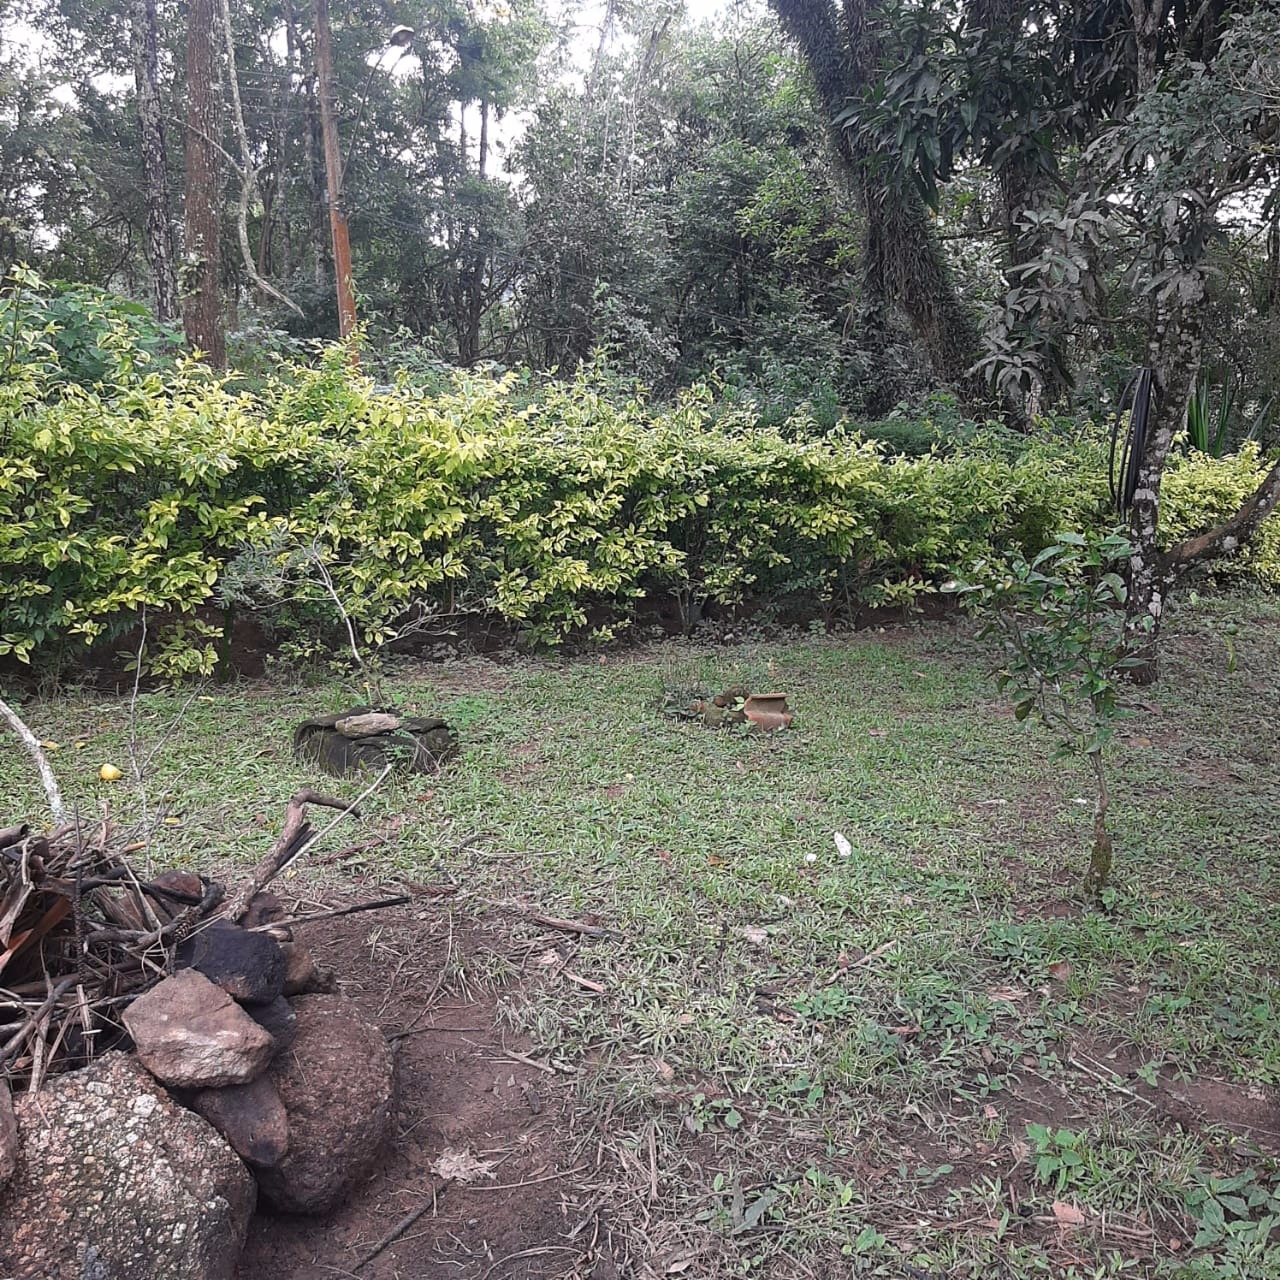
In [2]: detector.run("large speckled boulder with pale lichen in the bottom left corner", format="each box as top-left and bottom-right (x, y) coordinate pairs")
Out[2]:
(0, 1053), (255, 1280)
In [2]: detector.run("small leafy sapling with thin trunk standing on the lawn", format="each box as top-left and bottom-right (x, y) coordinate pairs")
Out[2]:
(954, 534), (1138, 893)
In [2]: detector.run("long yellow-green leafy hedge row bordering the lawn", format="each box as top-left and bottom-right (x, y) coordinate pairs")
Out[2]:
(0, 353), (1280, 669)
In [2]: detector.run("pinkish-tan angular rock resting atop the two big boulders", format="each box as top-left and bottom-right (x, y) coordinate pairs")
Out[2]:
(124, 969), (275, 1089)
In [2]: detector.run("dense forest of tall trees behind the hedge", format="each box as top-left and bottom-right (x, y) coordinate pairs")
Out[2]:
(0, 0), (1280, 439)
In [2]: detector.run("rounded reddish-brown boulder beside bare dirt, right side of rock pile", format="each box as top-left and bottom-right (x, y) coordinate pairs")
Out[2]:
(259, 996), (396, 1213)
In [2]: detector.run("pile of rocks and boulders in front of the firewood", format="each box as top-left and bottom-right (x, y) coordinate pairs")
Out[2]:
(0, 893), (396, 1280)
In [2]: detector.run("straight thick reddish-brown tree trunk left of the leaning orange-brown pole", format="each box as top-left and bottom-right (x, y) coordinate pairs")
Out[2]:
(182, 0), (227, 369)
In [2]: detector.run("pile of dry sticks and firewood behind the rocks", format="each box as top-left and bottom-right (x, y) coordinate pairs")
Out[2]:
(0, 791), (384, 1089)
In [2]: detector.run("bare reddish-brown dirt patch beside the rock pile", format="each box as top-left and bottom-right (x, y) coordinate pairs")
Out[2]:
(238, 906), (622, 1280)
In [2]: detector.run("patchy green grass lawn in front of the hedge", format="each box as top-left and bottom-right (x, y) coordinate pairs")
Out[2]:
(0, 598), (1280, 1280)
